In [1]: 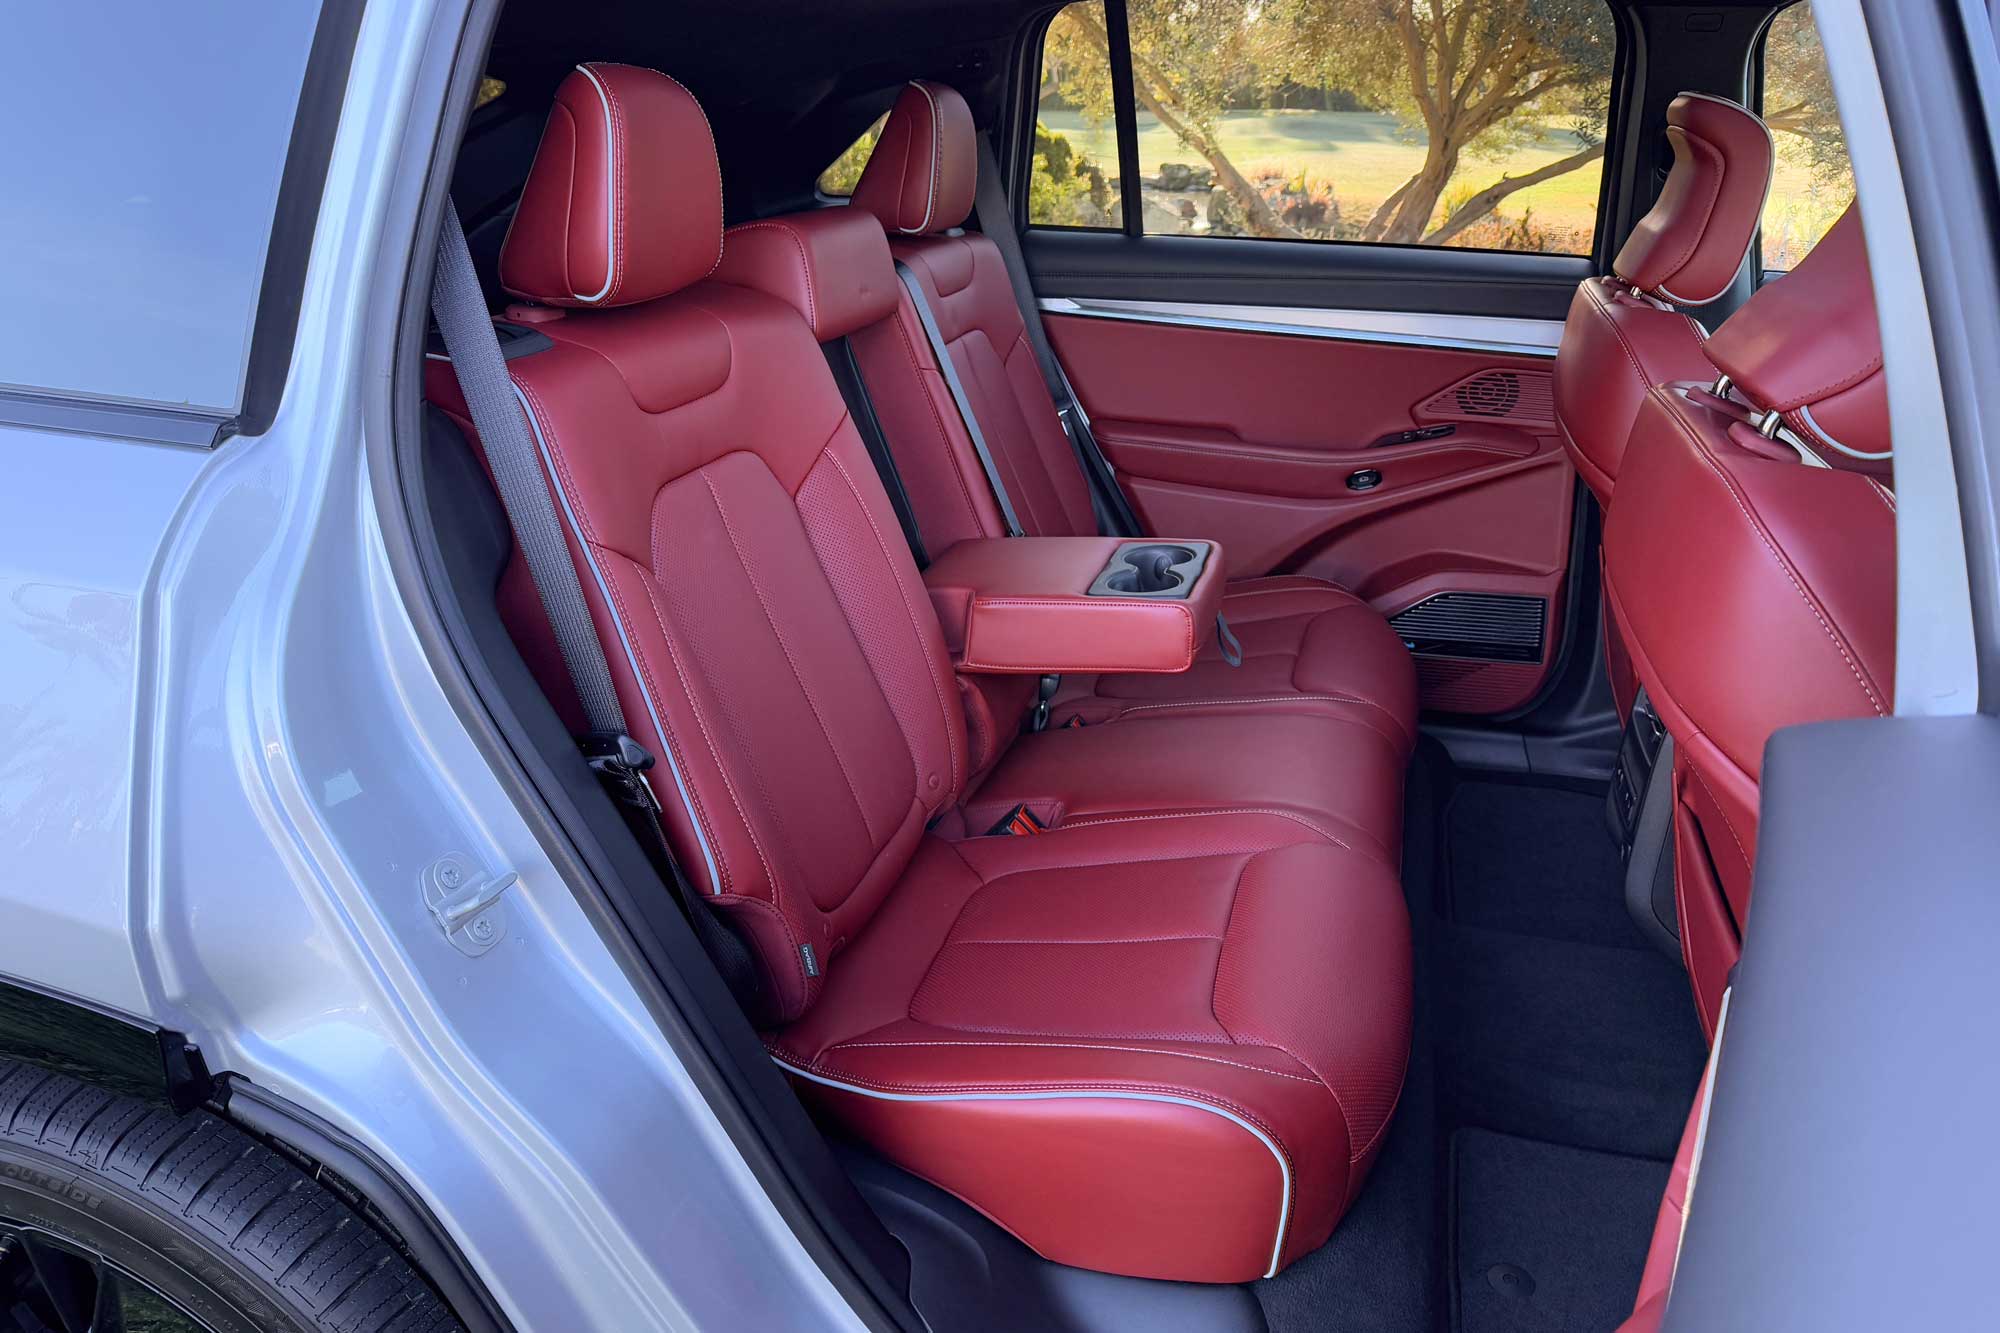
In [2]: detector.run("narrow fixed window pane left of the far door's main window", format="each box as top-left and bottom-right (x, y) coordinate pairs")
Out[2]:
(1028, 0), (1124, 230)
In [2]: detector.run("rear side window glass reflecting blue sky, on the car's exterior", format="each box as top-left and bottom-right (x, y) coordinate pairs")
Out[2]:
(0, 0), (318, 412)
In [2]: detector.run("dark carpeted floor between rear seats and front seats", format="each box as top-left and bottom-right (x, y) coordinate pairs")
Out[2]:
(1256, 743), (1704, 1333)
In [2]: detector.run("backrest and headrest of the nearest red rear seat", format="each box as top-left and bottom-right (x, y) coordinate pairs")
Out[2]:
(432, 64), (966, 1019)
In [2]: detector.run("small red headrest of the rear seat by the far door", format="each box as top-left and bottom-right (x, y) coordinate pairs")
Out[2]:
(852, 78), (980, 236)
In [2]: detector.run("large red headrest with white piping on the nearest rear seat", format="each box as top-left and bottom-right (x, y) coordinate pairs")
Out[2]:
(500, 62), (722, 306)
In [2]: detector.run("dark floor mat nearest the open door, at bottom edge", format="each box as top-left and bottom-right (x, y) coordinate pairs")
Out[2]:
(1452, 1129), (1668, 1333)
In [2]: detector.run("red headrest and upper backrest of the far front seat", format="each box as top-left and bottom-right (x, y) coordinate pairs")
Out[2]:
(1556, 92), (1772, 504)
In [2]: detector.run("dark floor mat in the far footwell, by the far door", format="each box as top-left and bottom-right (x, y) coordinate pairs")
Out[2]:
(1448, 783), (1650, 949)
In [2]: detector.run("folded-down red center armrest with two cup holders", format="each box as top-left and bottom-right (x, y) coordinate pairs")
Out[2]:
(924, 536), (1222, 675)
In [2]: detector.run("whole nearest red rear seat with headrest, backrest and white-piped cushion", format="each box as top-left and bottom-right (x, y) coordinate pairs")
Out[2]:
(430, 64), (1410, 1281)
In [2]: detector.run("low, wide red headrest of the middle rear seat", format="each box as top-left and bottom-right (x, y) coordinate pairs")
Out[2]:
(716, 206), (898, 342)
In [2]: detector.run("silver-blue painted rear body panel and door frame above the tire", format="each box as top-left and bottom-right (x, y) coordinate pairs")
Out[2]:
(0, 0), (856, 1333)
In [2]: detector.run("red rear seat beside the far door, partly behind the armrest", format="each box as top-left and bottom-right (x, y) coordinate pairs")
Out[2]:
(852, 80), (1416, 749)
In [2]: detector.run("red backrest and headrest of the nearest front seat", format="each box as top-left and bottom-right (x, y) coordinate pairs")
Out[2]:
(1604, 200), (1896, 1025)
